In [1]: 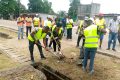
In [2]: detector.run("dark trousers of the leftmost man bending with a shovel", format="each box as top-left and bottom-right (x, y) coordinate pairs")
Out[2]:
(29, 41), (44, 61)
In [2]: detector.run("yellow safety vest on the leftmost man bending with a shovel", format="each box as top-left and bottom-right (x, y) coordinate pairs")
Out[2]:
(28, 28), (46, 42)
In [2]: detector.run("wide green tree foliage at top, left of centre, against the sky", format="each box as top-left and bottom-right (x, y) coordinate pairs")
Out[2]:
(28, 0), (54, 14)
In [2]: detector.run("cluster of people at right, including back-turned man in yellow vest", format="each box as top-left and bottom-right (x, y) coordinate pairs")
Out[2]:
(76, 13), (120, 74)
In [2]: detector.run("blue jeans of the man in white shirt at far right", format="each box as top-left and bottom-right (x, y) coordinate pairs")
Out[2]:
(108, 32), (117, 49)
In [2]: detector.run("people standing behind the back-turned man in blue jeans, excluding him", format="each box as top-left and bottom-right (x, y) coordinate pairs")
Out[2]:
(76, 13), (120, 51)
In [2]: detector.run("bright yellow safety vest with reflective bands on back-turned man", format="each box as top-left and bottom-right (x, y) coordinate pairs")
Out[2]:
(84, 25), (99, 48)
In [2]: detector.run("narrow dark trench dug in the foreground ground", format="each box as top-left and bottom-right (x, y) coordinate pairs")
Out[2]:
(32, 62), (72, 80)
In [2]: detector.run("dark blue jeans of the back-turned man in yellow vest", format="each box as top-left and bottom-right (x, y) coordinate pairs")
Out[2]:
(83, 48), (97, 71)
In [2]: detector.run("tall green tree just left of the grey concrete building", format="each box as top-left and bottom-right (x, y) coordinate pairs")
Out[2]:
(68, 0), (80, 20)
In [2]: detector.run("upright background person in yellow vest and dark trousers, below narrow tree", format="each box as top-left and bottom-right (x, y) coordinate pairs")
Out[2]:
(66, 17), (73, 39)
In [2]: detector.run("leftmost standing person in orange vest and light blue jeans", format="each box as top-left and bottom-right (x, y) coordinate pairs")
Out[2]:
(17, 15), (24, 40)
